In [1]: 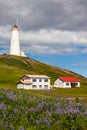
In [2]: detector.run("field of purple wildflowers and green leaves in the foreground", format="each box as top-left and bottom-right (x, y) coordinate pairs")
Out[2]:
(0, 88), (87, 130)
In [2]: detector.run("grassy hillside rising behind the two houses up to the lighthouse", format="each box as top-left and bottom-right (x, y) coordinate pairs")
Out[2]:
(0, 54), (87, 86)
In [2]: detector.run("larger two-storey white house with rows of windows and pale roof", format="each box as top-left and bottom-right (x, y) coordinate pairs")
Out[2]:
(17, 75), (50, 89)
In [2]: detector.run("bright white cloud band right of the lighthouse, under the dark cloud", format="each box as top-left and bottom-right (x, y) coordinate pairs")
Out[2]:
(20, 29), (87, 46)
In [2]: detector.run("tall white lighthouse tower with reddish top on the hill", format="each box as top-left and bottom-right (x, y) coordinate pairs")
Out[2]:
(10, 25), (20, 56)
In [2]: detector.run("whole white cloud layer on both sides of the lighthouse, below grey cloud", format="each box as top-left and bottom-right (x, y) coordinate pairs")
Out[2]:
(0, 26), (87, 54)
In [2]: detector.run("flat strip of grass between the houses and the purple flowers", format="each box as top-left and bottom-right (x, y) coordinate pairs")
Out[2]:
(0, 84), (87, 99)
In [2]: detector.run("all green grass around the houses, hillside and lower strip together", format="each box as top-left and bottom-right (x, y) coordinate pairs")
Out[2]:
(0, 55), (87, 101)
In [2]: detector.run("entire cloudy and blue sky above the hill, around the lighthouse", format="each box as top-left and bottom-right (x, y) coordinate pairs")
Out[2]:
(0, 0), (87, 77)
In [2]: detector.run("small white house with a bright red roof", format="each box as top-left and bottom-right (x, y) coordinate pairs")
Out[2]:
(54, 76), (80, 88)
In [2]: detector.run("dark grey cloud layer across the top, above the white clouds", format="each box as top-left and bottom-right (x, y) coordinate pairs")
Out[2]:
(0, 0), (87, 31)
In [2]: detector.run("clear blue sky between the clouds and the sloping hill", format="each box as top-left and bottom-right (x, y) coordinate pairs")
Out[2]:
(27, 54), (87, 77)
